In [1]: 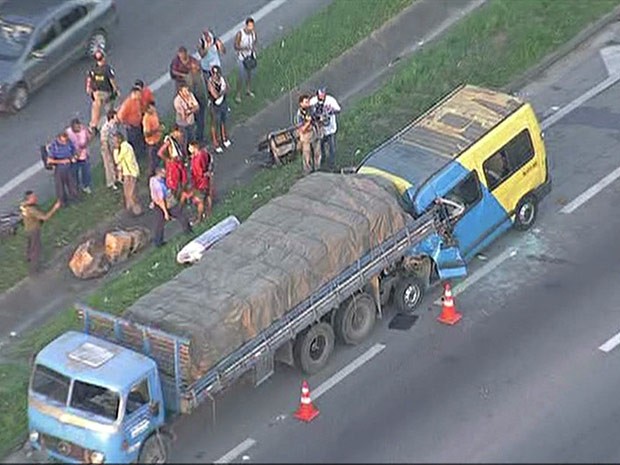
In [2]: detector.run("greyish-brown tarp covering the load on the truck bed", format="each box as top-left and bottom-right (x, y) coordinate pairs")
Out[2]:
(125, 173), (406, 379)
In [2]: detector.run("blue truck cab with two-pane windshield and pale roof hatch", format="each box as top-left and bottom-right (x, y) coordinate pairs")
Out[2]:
(28, 331), (165, 463)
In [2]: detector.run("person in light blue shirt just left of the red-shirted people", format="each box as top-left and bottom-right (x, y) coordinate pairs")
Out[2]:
(149, 167), (192, 247)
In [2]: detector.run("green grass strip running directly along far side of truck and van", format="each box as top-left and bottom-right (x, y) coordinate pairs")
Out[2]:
(0, 0), (620, 455)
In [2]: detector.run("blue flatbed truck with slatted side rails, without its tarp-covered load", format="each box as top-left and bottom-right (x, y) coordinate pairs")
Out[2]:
(28, 198), (462, 463)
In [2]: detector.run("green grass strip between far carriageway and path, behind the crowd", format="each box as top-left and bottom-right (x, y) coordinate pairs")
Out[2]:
(0, 0), (413, 292)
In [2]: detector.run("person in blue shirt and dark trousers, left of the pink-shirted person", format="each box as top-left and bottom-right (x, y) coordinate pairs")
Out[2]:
(47, 132), (78, 206)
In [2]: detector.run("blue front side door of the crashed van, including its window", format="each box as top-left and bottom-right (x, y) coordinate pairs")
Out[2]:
(443, 170), (510, 261)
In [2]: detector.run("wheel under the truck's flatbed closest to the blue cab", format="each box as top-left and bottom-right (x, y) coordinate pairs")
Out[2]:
(294, 322), (334, 375)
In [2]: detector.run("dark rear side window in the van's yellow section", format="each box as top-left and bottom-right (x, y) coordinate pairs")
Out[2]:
(482, 129), (534, 191)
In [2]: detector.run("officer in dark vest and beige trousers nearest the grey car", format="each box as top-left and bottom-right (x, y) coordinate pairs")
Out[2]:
(86, 50), (120, 132)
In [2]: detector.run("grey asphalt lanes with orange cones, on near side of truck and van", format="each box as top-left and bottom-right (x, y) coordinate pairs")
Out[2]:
(157, 24), (620, 463)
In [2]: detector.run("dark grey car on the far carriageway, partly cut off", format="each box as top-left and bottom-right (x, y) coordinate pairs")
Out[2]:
(0, 0), (118, 112)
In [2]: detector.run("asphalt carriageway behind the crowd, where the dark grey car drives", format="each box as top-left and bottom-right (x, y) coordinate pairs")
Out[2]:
(0, 0), (331, 211)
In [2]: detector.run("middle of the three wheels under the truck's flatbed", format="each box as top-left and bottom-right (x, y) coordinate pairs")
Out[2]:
(334, 293), (377, 345)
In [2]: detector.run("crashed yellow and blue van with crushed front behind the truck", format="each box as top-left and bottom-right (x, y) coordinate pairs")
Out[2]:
(357, 85), (551, 310)
